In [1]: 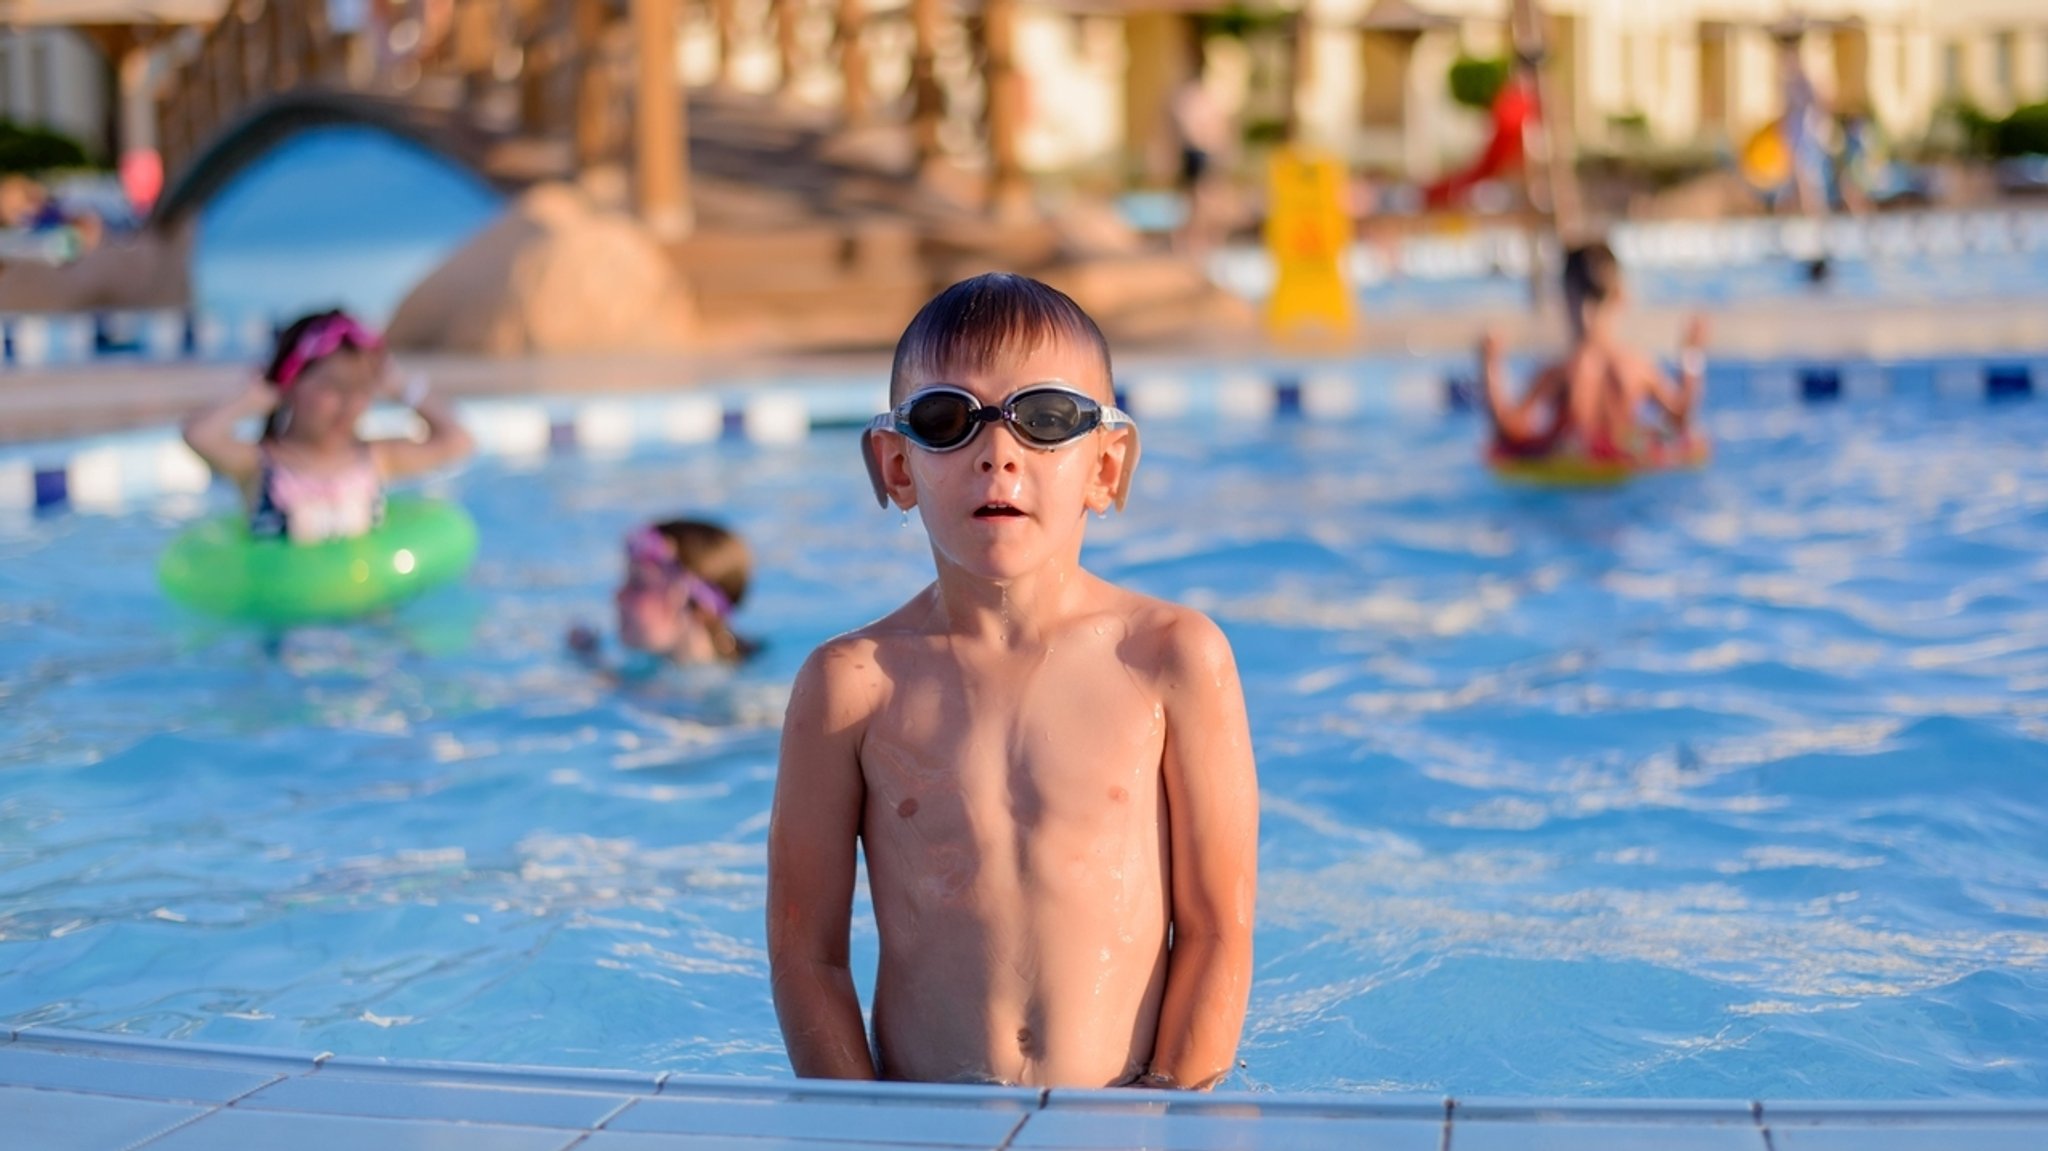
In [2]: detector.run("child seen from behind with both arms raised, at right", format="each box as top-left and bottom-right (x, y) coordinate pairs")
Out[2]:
(1479, 242), (1706, 461)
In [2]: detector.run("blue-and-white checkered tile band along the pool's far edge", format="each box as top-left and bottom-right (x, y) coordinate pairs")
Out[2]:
(0, 354), (2048, 512)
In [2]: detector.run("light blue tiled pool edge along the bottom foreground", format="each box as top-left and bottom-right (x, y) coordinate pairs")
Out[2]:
(0, 1028), (2048, 1151)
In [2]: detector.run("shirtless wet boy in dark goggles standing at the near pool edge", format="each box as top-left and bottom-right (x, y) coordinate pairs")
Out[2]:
(768, 274), (1257, 1088)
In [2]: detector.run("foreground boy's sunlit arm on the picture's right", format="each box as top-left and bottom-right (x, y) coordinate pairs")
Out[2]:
(1141, 610), (1260, 1090)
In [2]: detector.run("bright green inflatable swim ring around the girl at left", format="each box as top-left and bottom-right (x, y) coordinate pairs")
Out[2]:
(156, 498), (477, 623)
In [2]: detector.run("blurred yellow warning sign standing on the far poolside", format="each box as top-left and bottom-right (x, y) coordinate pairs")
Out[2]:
(1266, 150), (1352, 338)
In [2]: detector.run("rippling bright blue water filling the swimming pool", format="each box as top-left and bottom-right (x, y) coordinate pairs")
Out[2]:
(0, 397), (2048, 1100)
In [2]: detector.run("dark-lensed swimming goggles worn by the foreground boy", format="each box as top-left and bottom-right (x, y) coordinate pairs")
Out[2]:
(860, 383), (1139, 510)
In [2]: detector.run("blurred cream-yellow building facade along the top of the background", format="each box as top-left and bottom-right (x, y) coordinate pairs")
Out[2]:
(0, 0), (2048, 182)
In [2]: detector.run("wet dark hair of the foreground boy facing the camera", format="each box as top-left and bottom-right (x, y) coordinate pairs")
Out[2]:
(889, 272), (1112, 403)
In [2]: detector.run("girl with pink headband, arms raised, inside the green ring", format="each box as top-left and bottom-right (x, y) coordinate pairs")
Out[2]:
(184, 311), (471, 545)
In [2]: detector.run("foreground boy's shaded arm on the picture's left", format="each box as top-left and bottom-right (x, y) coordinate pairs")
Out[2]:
(768, 641), (874, 1079)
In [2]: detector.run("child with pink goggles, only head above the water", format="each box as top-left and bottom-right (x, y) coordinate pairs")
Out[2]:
(569, 520), (756, 664)
